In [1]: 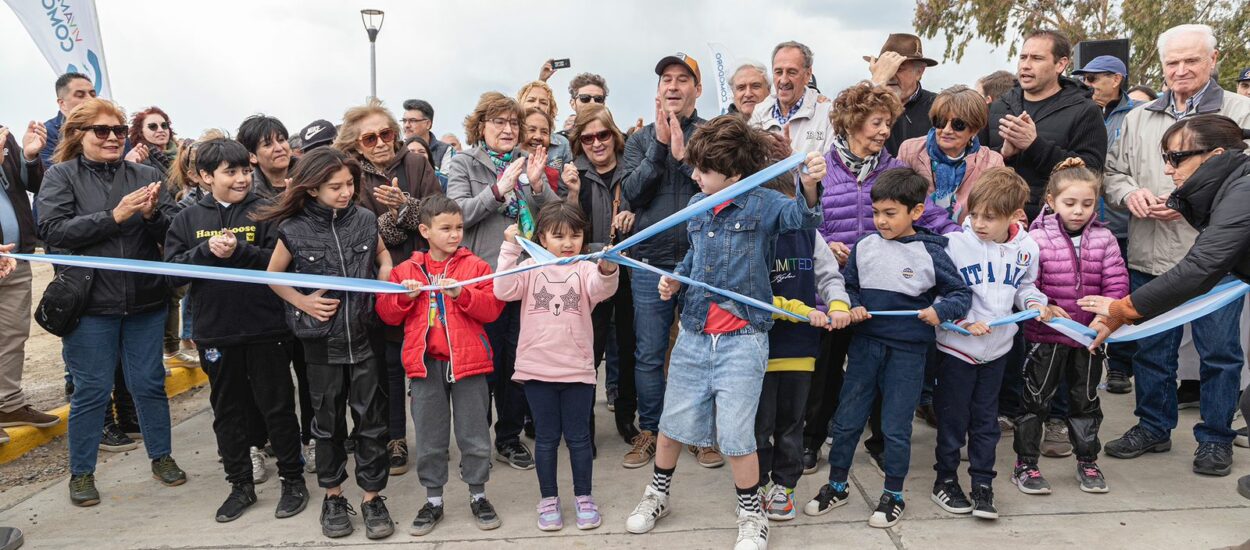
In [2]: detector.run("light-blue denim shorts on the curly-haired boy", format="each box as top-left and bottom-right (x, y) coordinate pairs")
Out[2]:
(660, 329), (769, 456)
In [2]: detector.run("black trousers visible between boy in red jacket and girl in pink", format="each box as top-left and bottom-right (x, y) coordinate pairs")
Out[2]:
(486, 301), (529, 449)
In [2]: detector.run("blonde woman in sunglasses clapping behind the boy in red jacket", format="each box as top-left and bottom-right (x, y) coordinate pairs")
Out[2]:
(334, 99), (443, 475)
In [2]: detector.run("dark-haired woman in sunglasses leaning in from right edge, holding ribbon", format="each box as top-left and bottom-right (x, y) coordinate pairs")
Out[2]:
(1076, 115), (1250, 499)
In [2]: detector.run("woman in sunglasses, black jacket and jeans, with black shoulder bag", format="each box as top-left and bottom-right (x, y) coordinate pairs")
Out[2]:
(38, 99), (186, 506)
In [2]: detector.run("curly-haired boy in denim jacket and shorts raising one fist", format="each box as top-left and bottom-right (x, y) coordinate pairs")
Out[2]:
(626, 116), (825, 549)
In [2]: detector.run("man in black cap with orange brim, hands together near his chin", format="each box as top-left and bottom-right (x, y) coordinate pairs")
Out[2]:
(623, 53), (724, 468)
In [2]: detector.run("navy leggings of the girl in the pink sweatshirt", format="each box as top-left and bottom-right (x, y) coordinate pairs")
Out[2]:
(521, 380), (595, 499)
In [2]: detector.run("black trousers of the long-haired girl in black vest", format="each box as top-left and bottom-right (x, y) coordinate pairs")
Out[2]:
(309, 358), (390, 491)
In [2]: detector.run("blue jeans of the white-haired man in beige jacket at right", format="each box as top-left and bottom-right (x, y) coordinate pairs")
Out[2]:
(1129, 270), (1244, 444)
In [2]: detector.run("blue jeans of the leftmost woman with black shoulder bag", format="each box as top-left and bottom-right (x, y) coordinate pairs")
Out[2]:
(63, 308), (170, 475)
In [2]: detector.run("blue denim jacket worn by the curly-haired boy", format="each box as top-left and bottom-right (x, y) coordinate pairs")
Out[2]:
(676, 189), (824, 334)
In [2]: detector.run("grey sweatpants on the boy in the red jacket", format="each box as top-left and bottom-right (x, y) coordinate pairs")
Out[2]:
(409, 356), (490, 496)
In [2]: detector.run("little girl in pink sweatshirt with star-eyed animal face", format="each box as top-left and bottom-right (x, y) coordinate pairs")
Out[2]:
(495, 201), (618, 531)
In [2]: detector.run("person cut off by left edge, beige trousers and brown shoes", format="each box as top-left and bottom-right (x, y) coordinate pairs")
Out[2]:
(0, 123), (60, 444)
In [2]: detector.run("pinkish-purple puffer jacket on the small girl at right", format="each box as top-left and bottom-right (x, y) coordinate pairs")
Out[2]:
(1024, 209), (1129, 348)
